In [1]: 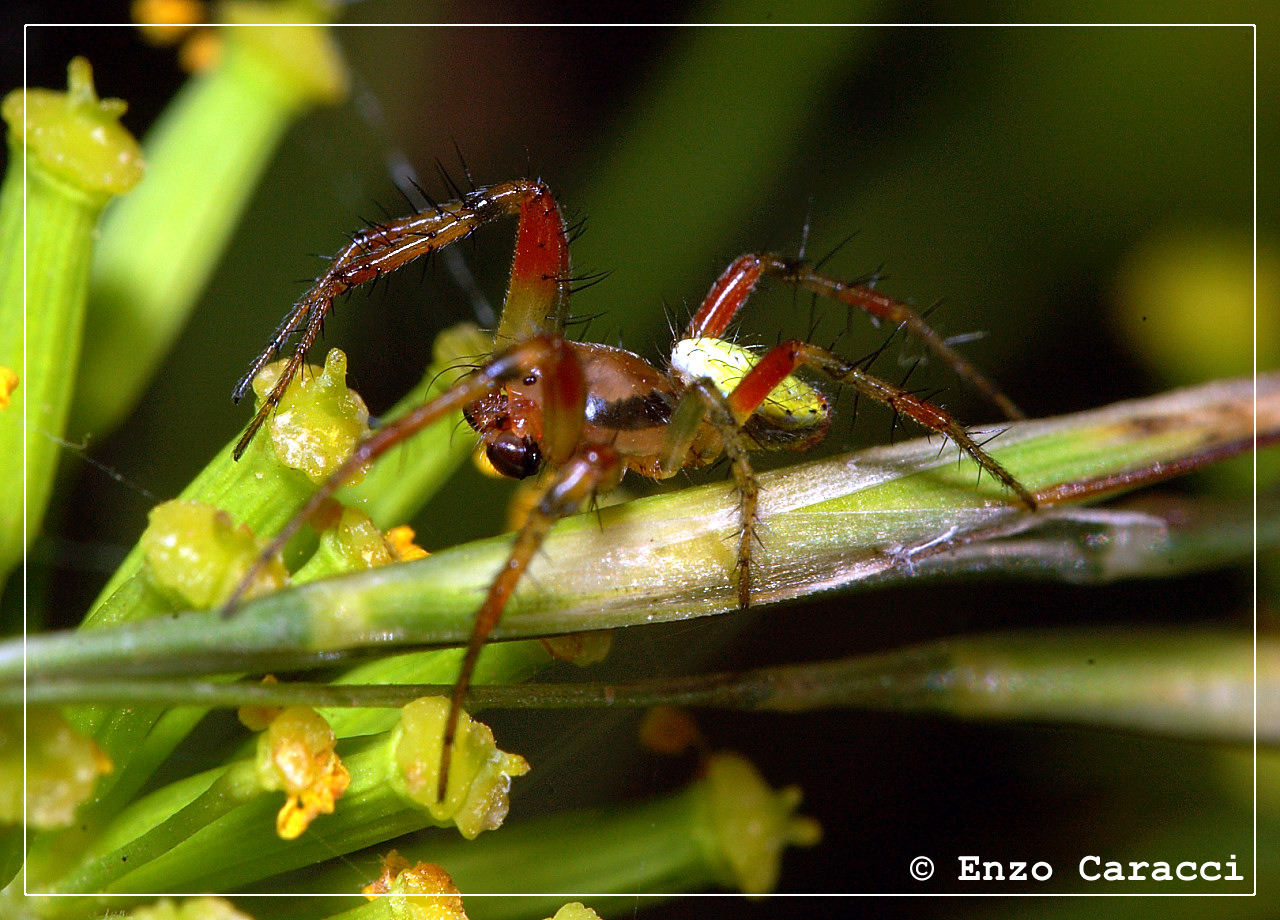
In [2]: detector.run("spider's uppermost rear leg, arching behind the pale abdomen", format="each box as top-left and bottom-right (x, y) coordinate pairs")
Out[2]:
(685, 252), (1027, 420)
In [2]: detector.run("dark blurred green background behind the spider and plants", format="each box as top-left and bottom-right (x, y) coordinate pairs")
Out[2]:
(10, 0), (1280, 916)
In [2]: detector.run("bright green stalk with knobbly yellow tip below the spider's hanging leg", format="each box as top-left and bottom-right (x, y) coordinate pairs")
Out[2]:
(42, 699), (529, 916)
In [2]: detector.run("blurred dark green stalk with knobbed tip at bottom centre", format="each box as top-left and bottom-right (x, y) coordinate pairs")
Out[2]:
(246, 752), (820, 920)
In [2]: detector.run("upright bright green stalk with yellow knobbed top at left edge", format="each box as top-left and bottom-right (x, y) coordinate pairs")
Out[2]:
(0, 58), (142, 581)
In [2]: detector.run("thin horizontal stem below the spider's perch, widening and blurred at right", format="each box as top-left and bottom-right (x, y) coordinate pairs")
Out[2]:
(12, 630), (1280, 743)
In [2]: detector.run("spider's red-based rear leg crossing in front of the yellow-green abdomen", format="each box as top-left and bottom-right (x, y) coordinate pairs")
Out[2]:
(728, 340), (1037, 511)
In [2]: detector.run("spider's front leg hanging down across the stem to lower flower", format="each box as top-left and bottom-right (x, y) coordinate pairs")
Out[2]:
(436, 444), (625, 801)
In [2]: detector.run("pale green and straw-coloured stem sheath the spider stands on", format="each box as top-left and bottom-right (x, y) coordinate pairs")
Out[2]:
(0, 375), (1280, 682)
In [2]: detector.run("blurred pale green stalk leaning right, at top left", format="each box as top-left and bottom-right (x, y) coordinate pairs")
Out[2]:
(69, 3), (347, 431)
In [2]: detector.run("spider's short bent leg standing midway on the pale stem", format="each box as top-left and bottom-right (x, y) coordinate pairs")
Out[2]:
(658, 377), (759, 609)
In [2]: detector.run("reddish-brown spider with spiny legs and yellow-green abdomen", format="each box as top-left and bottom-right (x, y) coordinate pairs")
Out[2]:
(225, 179), (1037, 800)
